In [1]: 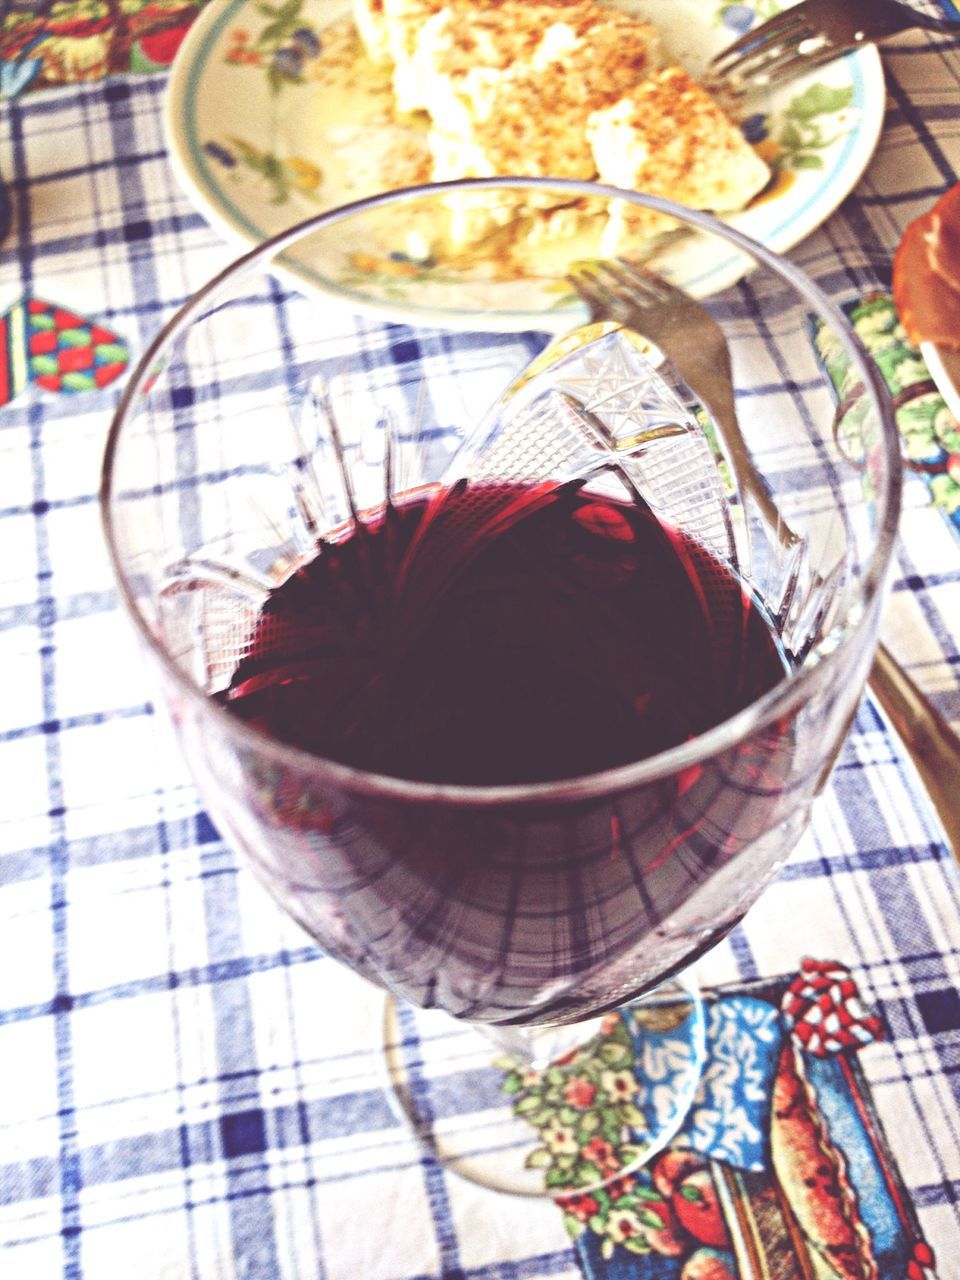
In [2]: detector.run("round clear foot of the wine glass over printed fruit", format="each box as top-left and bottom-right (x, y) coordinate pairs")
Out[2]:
(384, 974), (705, 1198)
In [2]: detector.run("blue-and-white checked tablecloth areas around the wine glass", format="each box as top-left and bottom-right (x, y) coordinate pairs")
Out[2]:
(0, 17), (960, 1280)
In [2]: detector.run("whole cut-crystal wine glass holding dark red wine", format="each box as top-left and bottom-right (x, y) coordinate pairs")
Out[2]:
(101, 179), (900, 1196)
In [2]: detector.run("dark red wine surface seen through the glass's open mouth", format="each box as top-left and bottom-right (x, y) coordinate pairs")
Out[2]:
(227, 484), (783, 786)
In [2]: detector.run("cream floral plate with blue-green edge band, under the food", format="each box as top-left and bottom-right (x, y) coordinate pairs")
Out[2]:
(165, 0), (884, 332)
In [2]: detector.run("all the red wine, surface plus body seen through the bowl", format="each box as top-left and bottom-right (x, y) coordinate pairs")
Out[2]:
(217, 484), (798, 1024)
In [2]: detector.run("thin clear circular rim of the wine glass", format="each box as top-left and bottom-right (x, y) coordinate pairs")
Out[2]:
(99, 177), (902, 808)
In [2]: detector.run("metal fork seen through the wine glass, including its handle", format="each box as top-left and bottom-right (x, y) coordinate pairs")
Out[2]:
(567, 254), (960, 861)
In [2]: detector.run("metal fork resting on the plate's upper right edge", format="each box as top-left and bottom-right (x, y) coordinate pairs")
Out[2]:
(708, 0), (960, 92)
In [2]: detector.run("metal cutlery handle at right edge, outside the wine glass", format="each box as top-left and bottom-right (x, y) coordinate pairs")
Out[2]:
(869, 645), (960, 861)
